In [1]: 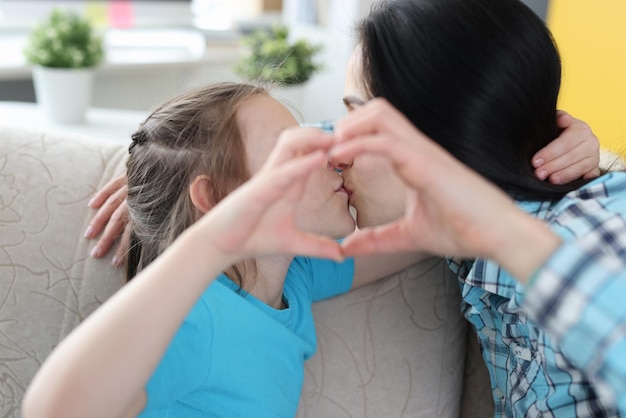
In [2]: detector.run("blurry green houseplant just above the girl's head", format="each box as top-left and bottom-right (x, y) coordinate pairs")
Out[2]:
(235, 25), (322, 114)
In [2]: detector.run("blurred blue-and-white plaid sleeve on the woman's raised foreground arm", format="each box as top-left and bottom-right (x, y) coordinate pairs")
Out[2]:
(524, 235), (626, 413)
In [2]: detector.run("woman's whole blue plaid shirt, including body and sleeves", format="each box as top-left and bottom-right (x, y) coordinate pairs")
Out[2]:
(450, 173), (626, 417)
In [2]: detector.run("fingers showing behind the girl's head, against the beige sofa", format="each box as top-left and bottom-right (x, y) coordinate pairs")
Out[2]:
(85, 174), (129, 265)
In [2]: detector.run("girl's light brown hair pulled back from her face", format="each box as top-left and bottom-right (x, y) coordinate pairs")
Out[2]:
(126, 83), (268, 286)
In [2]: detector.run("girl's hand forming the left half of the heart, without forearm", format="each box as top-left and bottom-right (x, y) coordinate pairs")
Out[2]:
(194, 128), (342, 260)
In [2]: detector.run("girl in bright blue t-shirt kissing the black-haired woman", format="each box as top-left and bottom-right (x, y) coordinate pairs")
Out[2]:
(23, 83), (415, 417)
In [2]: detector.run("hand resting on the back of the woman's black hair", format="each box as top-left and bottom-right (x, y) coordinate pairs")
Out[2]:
(532, 110), (600, 184)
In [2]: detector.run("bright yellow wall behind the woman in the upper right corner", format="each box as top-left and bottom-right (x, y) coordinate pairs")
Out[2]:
(547, 0), (626, 157)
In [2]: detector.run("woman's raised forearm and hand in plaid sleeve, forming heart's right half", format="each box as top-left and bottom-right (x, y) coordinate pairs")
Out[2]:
(331, 99), (626, 414)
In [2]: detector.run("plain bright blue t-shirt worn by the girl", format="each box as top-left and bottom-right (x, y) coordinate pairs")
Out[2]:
(140, 257), (354, 418)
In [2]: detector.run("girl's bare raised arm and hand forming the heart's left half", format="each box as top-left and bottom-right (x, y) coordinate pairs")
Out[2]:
(23, 134), (341, 418)
